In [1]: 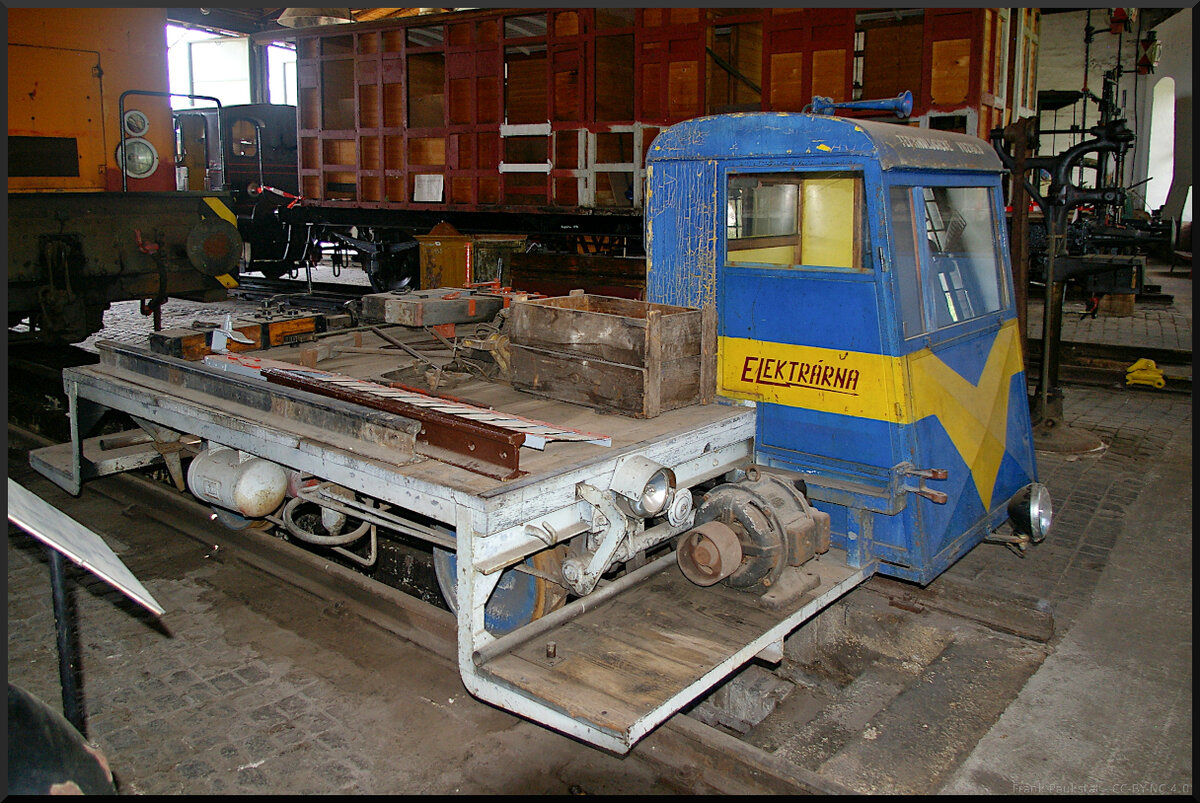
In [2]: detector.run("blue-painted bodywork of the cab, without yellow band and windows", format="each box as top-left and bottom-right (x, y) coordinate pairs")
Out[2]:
(646, 113), (1033, 582)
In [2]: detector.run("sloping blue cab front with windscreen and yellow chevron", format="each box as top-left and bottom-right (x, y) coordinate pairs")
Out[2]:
(888, 174), (1036, 581)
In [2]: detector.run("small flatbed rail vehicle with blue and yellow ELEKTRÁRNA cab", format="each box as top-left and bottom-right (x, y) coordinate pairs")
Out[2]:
(31, 104), (1051, 753)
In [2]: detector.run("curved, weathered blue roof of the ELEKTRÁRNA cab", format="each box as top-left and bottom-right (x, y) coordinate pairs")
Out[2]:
(646, 112), (1004, 173)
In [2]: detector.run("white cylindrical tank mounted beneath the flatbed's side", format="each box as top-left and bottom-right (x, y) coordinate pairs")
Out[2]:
(187, 449), (288, 519)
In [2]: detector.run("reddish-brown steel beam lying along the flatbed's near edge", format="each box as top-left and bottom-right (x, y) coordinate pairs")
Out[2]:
(262, 368), (526, 480)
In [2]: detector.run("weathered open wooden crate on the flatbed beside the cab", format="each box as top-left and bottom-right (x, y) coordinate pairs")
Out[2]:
(509, 292), (716, 418)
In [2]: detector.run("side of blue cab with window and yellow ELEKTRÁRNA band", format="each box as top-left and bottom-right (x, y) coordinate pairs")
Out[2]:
(718, 158), (907, 565)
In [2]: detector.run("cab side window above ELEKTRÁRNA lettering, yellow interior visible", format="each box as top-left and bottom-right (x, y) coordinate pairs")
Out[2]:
(725, 172), (871, 271)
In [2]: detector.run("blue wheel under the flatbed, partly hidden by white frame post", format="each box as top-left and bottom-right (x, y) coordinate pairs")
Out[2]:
(433, 547), (566, 636)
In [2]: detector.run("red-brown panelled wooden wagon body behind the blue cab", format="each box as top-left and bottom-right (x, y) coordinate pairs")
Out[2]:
(289, 8), (1038, 220)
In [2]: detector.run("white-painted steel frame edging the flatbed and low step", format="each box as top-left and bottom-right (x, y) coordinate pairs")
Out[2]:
(49, 357), (844, 753)
